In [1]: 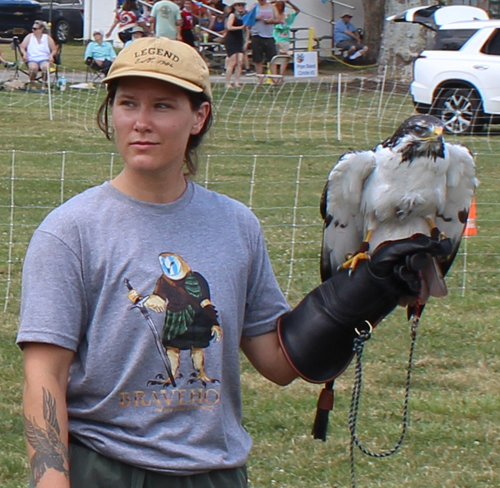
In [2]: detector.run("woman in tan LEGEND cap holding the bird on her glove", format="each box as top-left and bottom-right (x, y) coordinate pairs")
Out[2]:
(17, 38), (448, 488)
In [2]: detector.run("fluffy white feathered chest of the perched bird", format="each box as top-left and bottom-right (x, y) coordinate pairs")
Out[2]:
(361, 146), (449, 228)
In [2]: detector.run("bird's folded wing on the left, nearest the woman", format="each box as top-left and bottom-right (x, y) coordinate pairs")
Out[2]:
(320, 151), (376, 281)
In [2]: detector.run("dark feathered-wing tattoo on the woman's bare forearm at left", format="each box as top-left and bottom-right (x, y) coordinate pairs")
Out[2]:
(24, 388), (69, 486)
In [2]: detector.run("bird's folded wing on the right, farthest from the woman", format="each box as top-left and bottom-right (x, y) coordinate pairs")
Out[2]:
(436, 143), (477, 276)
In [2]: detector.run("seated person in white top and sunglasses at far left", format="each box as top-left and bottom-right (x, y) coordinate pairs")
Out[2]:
(19, 20), (59, 91)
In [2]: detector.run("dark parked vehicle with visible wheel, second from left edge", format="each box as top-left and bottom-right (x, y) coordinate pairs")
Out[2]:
(40, 0), (83, 44)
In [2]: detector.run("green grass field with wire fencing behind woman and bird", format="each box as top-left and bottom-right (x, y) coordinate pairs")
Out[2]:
(0, 59), (500, 488)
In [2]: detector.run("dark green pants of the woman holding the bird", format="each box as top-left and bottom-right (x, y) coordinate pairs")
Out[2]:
(47, 443), (248, 488)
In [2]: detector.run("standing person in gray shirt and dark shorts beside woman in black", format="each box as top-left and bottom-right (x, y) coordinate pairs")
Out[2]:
(251, 0), (281, 85)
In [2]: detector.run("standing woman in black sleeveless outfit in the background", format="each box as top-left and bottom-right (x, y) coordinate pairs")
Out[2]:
(225, 0), (246, 88)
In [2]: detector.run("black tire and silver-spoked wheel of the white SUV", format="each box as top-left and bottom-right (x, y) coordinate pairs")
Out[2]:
(436, 88), (484, 134)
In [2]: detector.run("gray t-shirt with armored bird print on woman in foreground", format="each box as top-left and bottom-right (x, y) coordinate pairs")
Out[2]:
(17, 182), (288, 474)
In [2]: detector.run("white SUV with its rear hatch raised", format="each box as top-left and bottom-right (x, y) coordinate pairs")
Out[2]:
(389, 6), (500, 134)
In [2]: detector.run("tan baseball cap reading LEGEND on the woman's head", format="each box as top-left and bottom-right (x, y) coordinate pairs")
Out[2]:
(103, 37), (212, 100)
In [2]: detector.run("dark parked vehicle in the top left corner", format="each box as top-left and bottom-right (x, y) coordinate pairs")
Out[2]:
(0, 0), (41, 39)
